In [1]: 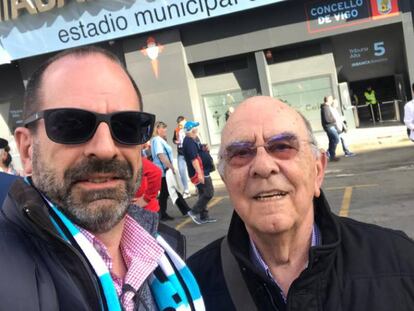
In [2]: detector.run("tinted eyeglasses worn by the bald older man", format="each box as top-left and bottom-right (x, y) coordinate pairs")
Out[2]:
(222, 134), (313, 166)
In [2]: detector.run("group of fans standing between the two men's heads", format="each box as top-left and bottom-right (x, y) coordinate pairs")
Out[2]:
(134, 116), (216, 225)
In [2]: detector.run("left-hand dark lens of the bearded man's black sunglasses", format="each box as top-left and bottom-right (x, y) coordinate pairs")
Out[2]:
(44, 109), (96, 144)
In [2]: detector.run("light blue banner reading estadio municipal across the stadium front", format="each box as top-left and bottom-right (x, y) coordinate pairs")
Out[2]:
(0, 0), (285, 64)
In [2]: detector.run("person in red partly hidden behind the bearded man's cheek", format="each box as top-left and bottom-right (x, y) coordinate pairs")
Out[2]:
(132, 157), (162, 213)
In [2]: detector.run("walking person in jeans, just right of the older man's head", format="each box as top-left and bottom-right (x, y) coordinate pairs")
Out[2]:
(321, 95), (339, 161)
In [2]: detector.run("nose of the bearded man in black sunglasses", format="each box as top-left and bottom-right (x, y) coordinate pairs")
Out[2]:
(84, 122), (119, 159)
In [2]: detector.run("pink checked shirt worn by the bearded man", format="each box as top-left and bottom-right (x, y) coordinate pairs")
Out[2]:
(79, 215), (164, 311)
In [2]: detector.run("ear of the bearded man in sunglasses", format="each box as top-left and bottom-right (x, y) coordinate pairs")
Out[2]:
(14, 127), (33, 175)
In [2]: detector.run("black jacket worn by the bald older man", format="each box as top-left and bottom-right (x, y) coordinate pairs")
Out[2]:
(188, 194), (414, 311)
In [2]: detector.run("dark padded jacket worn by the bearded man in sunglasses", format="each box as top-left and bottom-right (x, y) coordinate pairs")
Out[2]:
(0, 179), (184, 311)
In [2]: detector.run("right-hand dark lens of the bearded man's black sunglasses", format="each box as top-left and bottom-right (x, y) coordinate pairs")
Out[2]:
(111, 112), (152, 145)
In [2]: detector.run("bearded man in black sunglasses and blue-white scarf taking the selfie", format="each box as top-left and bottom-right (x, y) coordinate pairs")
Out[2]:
(0, 47), (204, 311)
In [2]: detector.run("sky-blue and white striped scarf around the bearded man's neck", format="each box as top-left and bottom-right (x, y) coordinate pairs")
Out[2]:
(32, 183), (205, 311)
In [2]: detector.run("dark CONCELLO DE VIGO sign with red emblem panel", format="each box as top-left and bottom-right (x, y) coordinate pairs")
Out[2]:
(305, 0), (399, 33)
